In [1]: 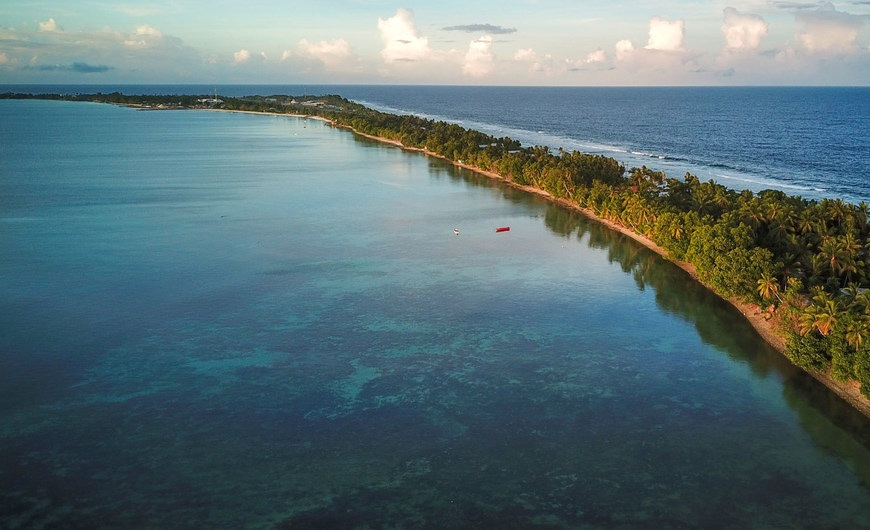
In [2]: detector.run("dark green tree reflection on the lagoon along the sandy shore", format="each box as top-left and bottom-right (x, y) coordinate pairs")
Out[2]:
(442, 155), (870, 448)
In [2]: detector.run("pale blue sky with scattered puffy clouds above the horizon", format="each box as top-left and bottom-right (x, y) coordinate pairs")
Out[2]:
(0, 0), (870, 86)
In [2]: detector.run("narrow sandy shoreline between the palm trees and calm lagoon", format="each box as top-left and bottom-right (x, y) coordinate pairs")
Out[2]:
(332, 113), (870, 419)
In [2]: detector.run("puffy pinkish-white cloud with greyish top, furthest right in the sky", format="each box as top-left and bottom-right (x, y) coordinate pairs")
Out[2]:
(795, 4), (867, 53)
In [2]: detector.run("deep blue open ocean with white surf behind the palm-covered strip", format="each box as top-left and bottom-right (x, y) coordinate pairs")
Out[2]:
(6, 85), (870, 203)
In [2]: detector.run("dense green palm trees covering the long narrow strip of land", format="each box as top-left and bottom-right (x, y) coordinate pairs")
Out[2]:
(10, 93), (870, 397)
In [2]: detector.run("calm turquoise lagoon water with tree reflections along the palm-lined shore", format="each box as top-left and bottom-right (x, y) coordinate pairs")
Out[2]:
(0, 101), (870, 528)
